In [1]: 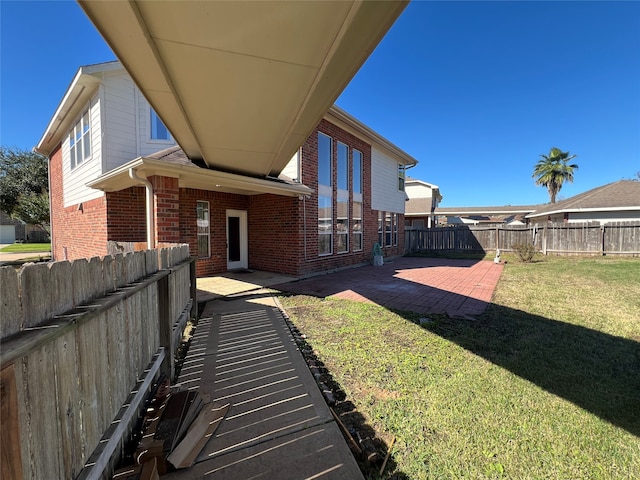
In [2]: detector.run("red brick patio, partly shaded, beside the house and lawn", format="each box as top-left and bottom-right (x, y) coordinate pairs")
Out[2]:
(274, 257), (503, 317)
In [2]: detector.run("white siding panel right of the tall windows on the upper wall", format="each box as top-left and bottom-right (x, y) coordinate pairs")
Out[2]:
(371, 147), (406, 213)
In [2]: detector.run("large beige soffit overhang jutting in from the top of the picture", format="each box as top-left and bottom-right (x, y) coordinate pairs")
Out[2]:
(79, 0), (407, 175)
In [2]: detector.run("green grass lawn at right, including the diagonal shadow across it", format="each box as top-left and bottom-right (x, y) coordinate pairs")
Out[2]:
(281, 257), (640, 480)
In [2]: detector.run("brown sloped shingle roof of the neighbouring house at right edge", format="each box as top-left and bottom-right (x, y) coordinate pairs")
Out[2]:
(527, 180), (640, 218)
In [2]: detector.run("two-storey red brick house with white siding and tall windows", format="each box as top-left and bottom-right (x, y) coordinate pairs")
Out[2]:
(36, 62), (417, 276)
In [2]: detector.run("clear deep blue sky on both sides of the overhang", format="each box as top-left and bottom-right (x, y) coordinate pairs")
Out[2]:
(0, 0), (640, 206)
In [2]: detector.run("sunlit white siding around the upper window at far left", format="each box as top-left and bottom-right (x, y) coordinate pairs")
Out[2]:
(62, 91), (103, 207)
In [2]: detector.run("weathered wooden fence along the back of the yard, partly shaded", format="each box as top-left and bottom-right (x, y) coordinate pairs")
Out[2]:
(404, 222), (640, 255)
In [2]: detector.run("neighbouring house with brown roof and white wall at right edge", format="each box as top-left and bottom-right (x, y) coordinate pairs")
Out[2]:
(526, 180), (640, 224)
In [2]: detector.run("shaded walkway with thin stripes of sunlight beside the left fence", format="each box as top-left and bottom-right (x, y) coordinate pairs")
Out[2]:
(163, 291), (363, 480)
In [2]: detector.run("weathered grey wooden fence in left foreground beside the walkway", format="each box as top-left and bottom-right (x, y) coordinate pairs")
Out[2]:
(0, 245), (196, 479)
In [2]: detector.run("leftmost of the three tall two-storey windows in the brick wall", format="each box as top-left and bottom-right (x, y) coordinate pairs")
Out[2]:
(318, 132), (333, 255)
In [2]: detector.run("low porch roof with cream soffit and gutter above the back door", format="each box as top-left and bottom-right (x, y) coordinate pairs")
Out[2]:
(87, 146), (313, 196)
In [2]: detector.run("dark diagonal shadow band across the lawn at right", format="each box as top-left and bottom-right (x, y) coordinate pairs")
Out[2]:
(398, 304), (640, 436)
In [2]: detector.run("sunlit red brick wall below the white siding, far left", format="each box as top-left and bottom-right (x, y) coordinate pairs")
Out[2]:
(49, 146), (107, 260)
